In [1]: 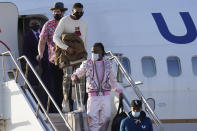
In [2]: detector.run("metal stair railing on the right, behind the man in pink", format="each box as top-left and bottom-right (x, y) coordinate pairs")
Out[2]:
(106, 51), (164, 131)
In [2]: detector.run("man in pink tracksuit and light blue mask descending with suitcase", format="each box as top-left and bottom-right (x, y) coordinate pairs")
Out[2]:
(72, 43), (122, 131)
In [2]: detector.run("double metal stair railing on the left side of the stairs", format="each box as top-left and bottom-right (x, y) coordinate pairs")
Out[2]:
(0, 51), (73, 131)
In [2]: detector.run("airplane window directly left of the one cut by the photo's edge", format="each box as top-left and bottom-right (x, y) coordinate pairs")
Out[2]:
(167, 57), (181, 76)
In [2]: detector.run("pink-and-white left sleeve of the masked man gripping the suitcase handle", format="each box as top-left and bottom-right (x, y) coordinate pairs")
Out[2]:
(71, 61), (87, 80)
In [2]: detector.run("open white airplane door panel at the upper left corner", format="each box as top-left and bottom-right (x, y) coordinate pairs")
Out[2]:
(0, 2), (18, 57)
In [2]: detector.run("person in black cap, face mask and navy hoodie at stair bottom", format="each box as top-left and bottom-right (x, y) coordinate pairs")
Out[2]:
(120, 100), (153, 131)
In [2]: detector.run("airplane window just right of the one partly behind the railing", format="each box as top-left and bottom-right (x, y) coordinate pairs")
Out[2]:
(142, 57), (156, 77)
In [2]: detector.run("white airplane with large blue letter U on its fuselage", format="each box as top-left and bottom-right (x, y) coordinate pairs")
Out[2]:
(0, 0), (197, 131)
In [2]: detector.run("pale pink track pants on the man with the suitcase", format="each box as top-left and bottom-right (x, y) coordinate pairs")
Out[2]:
(87, 95), (111, 131)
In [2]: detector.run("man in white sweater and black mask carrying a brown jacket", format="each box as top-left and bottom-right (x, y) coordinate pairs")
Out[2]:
(53, 3), (88, 112)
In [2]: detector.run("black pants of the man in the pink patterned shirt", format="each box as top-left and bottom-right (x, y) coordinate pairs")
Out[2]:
(49, 63), (63, 112)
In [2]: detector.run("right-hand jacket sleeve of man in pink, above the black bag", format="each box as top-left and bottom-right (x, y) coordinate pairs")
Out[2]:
(109, 64), (122, 94)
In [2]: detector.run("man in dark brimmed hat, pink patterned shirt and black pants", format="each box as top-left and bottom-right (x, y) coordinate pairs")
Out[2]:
(37, 2), (68, 112)
